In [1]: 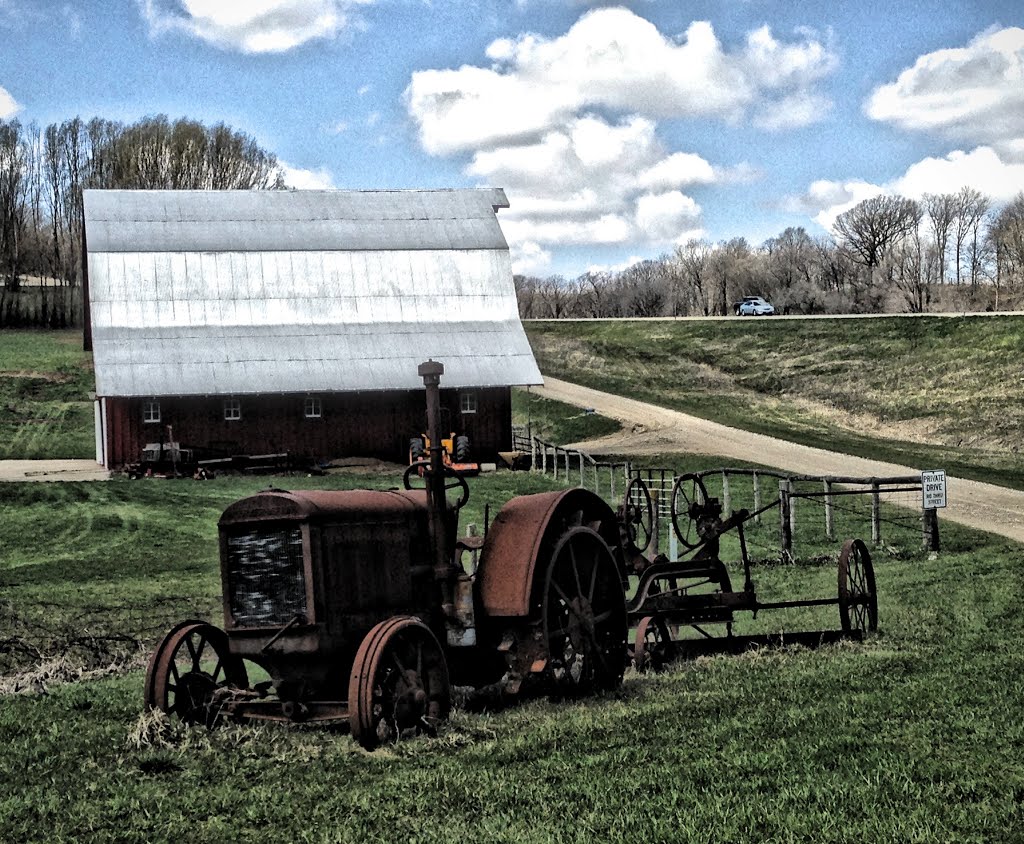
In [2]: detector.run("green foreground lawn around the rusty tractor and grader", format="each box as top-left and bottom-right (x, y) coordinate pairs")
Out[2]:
(0, 473), (1024, 842)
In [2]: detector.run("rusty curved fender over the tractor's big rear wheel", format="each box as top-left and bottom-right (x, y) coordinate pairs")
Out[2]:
(476, 489), (622, 617)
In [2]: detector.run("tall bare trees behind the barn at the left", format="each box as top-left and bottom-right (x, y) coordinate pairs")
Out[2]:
(0, 115), (285, 328)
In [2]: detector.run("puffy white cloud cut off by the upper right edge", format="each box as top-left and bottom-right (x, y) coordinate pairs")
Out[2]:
(864, 28), (1024, 143)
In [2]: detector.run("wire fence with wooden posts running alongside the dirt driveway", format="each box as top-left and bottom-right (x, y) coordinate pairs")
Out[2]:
(530, 437), (939, 560)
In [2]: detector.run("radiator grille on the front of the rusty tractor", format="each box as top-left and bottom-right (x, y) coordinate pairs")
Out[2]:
(227, 528), (307, 627)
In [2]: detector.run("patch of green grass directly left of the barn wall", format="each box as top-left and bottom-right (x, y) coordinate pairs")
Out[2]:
(0, 330), (96, 460)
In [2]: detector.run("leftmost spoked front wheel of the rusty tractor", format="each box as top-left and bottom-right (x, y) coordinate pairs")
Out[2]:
(145, 621), (249, 726)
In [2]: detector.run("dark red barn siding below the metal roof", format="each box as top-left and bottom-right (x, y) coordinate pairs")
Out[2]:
(106, 387), (512, 468)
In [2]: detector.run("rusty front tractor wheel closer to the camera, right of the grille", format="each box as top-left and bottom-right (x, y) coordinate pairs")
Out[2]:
(348, 616), (452, 750)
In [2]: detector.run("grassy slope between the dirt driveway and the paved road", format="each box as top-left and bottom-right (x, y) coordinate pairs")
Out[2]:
(526, 317), (1024, 489)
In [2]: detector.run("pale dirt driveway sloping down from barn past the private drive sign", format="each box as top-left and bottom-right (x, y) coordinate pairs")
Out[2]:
(532, 376), (1024, 542)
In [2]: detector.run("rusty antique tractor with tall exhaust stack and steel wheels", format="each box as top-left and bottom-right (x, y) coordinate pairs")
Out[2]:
(144, 361), (627, 749)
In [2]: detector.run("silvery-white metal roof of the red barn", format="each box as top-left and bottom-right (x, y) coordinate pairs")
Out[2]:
(85, 189), (542, 396)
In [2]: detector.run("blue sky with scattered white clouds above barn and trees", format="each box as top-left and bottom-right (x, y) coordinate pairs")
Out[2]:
(0, 0), (1024, 277)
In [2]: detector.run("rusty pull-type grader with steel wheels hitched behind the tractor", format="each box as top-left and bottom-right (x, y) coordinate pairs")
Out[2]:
(622, 474), (879, 671)
